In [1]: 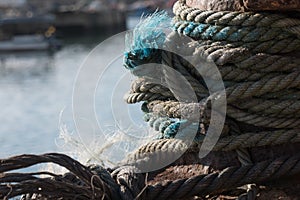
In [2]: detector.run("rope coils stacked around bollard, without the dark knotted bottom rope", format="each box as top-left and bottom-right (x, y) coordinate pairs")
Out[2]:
(120, 1), (300, 199)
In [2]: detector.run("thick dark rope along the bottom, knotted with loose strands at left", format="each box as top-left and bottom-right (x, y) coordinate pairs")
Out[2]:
(0, 154), (300, 200)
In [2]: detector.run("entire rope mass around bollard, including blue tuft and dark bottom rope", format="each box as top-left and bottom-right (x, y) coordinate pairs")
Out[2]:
(0, 1), (300, 200)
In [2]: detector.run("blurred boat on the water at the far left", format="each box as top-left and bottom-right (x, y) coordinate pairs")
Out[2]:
(0, 35), (61, 52)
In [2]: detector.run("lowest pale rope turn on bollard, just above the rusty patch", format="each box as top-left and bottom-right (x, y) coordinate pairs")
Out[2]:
(127, 129), (300, 163)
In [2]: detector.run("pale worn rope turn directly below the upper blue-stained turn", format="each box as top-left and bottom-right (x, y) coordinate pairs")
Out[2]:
(163, 36), (300, 85)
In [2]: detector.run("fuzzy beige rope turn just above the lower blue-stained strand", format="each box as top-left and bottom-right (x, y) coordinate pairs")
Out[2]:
(138, 94), (299, 130)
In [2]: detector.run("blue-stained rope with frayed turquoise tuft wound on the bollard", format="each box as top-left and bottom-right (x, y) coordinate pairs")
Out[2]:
(124, 7), (300, 143)
